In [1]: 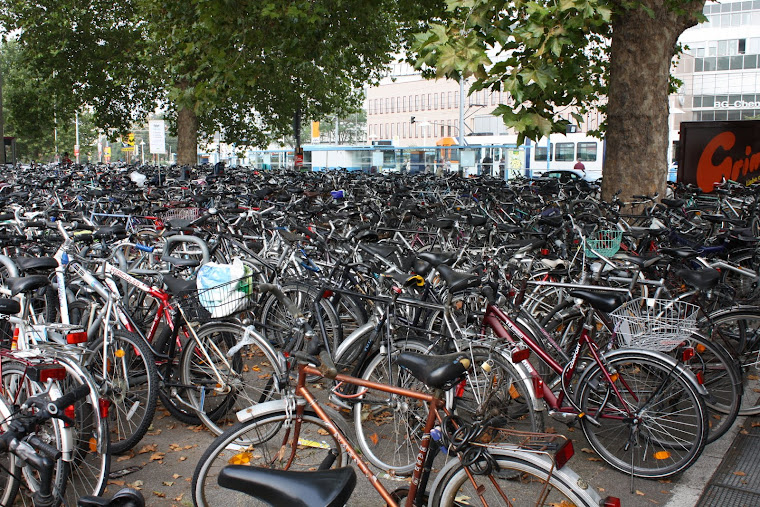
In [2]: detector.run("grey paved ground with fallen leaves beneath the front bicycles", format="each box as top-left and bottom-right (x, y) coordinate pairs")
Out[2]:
(96, 406), (760, 507)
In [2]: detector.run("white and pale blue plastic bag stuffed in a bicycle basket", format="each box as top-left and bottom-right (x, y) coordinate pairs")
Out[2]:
(196, 259), (247, 319)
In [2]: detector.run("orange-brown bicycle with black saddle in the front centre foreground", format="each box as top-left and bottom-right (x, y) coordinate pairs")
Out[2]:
(192, 288), (616, 506)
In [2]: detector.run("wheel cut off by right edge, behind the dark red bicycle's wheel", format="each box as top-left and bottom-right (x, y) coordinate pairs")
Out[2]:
(699, 308), (760, 415)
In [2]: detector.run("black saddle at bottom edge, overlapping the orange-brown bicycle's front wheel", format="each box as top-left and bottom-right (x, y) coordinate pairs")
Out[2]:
(218, 465), (356, 507)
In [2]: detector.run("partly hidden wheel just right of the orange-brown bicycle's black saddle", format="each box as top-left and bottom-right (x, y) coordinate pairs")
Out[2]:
(454, 346), (544, 433)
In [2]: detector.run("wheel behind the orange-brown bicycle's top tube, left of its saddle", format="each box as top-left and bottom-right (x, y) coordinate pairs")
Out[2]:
(354, 340), (430, 475)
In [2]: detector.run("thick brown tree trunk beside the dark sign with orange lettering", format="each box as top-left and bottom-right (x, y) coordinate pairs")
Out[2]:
(602, 0), (704, 200)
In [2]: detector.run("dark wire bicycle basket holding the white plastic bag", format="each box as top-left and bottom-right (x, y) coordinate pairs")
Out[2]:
(176, 275), (256, 322)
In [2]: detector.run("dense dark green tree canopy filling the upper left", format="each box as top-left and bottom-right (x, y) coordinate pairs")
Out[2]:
(0, 0), (443, 159)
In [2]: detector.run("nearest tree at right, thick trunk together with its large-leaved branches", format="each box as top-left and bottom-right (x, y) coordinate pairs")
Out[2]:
(413, 0), (705, 197)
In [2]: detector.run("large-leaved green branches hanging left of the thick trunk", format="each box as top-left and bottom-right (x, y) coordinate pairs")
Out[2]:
(413, 0), (613, 142)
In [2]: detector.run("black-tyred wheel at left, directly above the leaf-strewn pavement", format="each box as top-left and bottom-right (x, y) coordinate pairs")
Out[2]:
(86, 330), (158, 454)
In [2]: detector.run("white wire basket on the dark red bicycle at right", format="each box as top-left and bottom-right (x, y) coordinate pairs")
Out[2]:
(610, 298), (699, 352)
